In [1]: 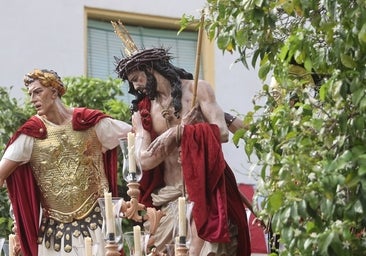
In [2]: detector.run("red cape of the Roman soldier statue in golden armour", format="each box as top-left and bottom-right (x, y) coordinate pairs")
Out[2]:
(6, 108), (117, 256)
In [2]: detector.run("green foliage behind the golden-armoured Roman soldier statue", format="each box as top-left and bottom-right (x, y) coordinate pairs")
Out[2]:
(0, 77), (130, 237)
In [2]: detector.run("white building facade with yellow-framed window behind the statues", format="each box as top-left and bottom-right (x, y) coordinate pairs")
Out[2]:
(0, 0), (261, 184)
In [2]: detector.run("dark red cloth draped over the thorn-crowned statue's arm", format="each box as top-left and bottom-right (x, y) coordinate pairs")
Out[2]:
(181, 123), (251, 256)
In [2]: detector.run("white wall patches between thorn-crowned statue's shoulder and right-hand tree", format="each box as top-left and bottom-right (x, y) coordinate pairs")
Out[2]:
(215, 51), (261, 184)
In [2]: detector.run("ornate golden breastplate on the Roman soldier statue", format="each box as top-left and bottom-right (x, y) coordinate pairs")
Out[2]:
(30, 120), (108, 223)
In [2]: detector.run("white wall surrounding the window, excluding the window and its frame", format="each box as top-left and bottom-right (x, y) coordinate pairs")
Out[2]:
(0, 0), (260, 183)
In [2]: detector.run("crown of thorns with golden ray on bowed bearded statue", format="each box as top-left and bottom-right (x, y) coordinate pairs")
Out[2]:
(111, 21), (171, 80)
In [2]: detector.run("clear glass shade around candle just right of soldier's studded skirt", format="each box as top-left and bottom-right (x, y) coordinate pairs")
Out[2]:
(98, 197), (123, 251)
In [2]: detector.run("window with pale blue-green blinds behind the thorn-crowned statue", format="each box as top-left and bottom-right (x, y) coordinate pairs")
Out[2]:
(87, 19), (202, 102)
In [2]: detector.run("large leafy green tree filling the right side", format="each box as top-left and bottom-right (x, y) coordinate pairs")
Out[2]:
(182, 0), (366, 256)
